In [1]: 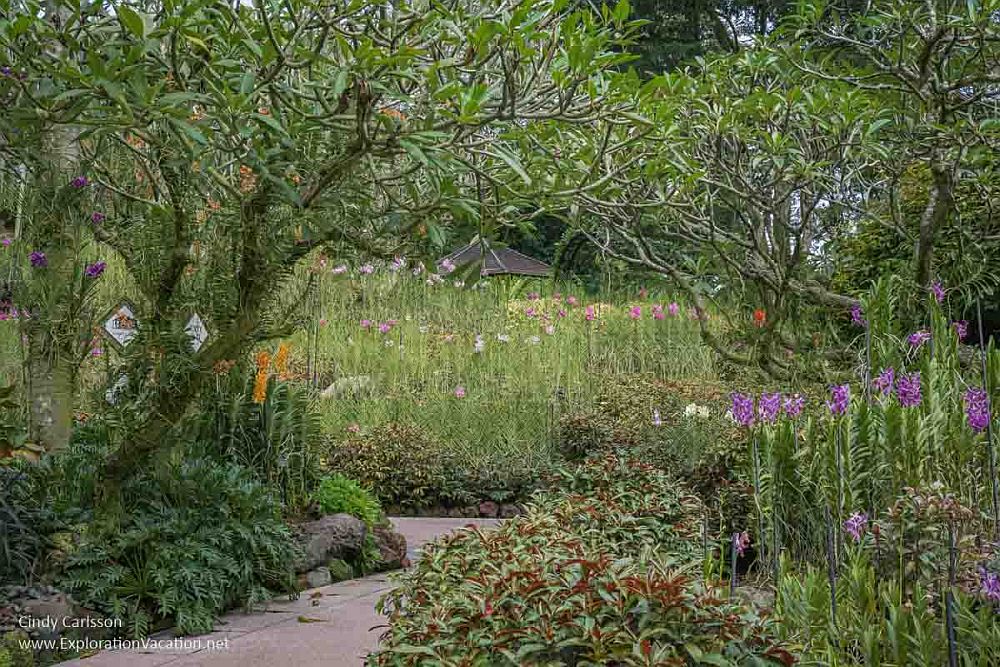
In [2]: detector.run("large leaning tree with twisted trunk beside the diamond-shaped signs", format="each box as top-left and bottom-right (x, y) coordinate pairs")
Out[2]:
(0, 0), (631, 479)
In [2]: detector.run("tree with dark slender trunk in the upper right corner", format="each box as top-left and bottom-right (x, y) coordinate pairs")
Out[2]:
(791, 0), (1000, 288)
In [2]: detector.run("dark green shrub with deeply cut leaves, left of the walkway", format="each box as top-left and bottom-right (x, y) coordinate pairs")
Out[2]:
(59, 459), (294, 636)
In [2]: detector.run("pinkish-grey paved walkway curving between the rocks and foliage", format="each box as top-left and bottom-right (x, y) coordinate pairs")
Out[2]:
(62, 518), (496, 667)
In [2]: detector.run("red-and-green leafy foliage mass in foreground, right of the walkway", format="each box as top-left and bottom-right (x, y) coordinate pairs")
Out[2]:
(370, 455), (791, 665)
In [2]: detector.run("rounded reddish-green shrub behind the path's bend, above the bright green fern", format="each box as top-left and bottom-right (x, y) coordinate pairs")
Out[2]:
(327, 424), (466, 508)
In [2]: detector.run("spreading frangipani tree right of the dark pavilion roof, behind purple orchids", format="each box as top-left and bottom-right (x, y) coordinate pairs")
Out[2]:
(528, 49), (878, 374)
